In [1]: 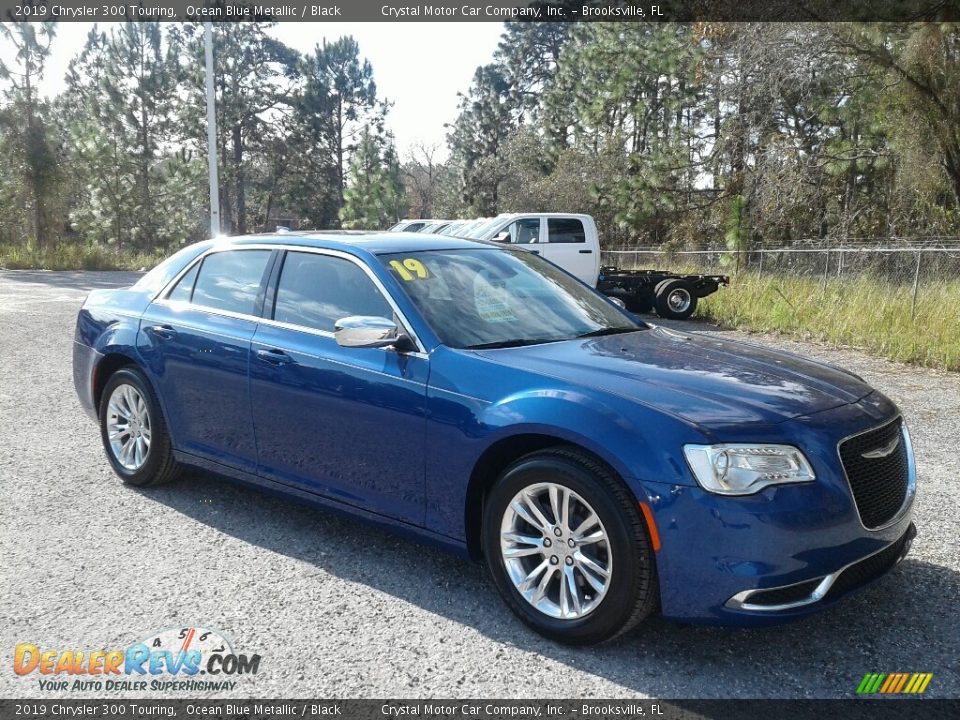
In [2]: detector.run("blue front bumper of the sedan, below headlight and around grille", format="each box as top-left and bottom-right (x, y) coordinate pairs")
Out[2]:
(637, 403), (916, 625)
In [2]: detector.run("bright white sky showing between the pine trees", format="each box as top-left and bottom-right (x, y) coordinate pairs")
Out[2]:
(22, 22), (503, 160)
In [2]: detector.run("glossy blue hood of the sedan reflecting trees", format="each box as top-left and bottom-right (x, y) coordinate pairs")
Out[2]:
(479, 327), (872, 429)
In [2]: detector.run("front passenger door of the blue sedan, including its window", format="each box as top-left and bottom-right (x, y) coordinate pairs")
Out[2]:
(250, 250), (429, 525)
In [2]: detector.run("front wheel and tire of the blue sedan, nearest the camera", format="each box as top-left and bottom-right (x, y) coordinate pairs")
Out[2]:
(482, 448), (659, 645)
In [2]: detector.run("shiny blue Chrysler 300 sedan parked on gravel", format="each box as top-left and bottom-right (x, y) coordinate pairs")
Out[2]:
(73, 232), (916, 644)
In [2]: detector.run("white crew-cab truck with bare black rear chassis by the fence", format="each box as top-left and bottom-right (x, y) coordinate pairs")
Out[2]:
(464, 213), (730, 320)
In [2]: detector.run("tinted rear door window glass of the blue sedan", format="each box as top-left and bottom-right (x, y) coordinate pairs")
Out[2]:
(193, 250), (270, 315)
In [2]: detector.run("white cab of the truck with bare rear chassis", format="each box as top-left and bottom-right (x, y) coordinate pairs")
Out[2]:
(470, 213), (600, 287)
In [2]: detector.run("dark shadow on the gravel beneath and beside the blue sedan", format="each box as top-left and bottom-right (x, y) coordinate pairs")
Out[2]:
(142, 471), (960, 698)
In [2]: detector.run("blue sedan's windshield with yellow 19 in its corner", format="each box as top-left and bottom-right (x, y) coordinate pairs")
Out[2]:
(381, 248), (647, 348)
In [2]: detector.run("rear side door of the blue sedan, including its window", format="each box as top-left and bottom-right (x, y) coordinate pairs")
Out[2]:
(138, 249), (273, 472)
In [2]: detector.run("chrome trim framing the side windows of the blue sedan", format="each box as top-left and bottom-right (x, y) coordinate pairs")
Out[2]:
(153, 243), (428, 358)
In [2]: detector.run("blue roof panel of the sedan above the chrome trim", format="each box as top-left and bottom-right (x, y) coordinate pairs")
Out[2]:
(227, 230), (493, 255)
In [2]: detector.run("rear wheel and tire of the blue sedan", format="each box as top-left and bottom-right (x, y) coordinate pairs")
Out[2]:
(100, 367), (180, 487)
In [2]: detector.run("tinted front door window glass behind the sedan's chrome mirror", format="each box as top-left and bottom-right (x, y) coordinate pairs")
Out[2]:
(273, 252), (393, 332)
